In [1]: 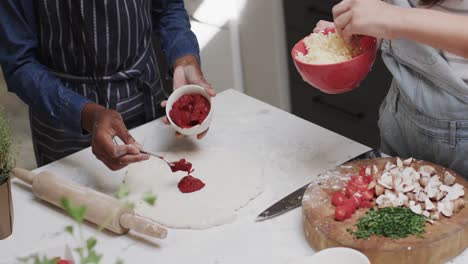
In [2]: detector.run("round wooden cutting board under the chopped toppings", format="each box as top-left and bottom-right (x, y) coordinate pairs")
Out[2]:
(302, 158), (468, 264)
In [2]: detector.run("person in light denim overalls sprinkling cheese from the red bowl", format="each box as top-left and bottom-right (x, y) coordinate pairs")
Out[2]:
(315, 0), (468, 179)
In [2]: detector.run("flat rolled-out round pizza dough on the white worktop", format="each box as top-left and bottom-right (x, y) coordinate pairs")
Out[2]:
(124, 151), (263, 229)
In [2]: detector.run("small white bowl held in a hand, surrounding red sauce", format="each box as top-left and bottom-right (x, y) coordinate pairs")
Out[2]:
(166, 85), (213, 136)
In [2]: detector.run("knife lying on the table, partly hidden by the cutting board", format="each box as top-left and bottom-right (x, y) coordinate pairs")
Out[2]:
(255, 149), (382, 222)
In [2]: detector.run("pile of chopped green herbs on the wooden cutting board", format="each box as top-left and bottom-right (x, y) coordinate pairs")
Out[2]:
(346, 207), (426, 239)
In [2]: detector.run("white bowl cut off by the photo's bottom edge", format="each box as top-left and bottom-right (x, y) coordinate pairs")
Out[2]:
(293, 247), (370, 264)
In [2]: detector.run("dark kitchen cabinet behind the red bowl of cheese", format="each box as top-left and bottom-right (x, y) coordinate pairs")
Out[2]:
(283, 0), (392, 147)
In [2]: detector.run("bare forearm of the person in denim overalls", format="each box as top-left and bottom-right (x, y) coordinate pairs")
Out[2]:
(392, 7), (468, 58)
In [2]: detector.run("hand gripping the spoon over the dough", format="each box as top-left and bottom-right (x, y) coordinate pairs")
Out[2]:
(81, 103), (149, 171)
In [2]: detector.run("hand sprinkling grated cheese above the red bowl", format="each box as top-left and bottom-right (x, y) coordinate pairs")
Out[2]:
(332, 0), (399, 42)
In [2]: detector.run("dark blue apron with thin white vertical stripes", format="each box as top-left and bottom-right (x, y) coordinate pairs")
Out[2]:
(30, 0), (167, 166)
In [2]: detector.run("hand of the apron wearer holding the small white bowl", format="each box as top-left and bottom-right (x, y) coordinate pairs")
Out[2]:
(161, 55), (216, 139)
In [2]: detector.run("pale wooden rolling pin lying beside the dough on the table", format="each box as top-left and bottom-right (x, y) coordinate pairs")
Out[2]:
(13, 168), (167, 239)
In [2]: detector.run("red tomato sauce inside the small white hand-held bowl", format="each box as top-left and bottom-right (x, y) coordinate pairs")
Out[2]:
(169, 94), (211, 128)
